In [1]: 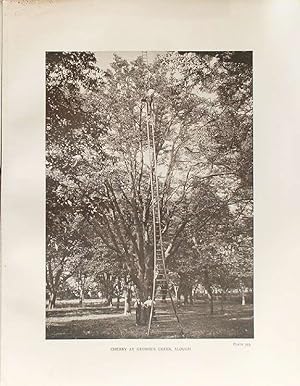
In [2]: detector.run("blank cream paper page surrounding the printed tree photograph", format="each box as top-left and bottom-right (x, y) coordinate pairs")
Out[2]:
(1, 0), (300, 386)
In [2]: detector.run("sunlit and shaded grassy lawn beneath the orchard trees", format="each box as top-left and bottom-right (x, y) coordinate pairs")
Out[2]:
(46, 302), (253, 339)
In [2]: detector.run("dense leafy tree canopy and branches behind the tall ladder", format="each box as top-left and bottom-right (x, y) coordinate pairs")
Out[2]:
(46, 52), (253, 310)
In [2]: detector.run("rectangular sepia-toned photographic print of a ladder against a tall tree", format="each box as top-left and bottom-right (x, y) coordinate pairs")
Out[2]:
(45, 51), (254, 339)
